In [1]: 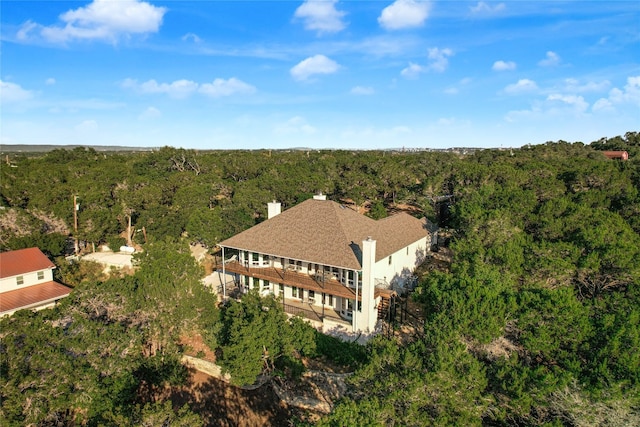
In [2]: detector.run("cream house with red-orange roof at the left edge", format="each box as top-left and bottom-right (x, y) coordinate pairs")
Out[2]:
(0, 248), (71, 316)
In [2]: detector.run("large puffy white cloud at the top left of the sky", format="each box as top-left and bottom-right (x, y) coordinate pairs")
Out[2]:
(17, 0), (167, 44)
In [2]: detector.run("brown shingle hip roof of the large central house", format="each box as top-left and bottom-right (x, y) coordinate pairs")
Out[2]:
(219, 199), (428, 270)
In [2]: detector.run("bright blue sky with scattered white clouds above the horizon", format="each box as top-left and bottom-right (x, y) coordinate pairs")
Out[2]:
(0, 0), (640, 149)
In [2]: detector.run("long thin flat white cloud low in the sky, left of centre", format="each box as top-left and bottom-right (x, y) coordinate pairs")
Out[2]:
(122, 77), (256, 99)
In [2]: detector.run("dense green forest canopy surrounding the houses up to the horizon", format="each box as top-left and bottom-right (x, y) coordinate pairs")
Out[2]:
(0, 132), (640, 426)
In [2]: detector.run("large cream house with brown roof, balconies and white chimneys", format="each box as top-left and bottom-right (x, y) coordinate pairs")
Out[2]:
(218, 195), (433, 333)
